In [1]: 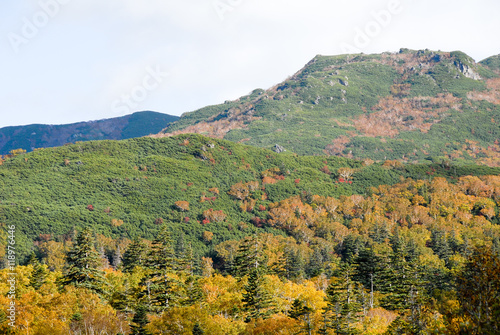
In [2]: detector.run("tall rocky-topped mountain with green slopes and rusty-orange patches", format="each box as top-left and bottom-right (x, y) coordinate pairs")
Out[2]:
(155, 49), (500, 166)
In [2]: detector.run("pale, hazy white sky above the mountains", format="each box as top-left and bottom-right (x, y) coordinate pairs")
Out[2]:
(0, 0), (500, 127)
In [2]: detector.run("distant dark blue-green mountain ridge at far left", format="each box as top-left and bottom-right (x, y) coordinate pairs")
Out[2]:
(0, 111), (178, 155)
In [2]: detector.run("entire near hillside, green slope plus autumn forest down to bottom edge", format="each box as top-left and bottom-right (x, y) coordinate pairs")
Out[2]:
(0, 134), (500, 334)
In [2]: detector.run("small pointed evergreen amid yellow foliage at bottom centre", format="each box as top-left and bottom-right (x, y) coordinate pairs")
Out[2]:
(242, 267), (271, 322)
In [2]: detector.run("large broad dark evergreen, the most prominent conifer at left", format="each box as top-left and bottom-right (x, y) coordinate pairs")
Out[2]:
(61, 228), (107, 294)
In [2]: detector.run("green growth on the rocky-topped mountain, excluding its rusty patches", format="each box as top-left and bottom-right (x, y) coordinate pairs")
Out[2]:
(162, 50), (500, 163)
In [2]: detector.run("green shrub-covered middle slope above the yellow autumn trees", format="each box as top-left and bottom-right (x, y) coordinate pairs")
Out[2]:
(0, 134), (500, 255)
